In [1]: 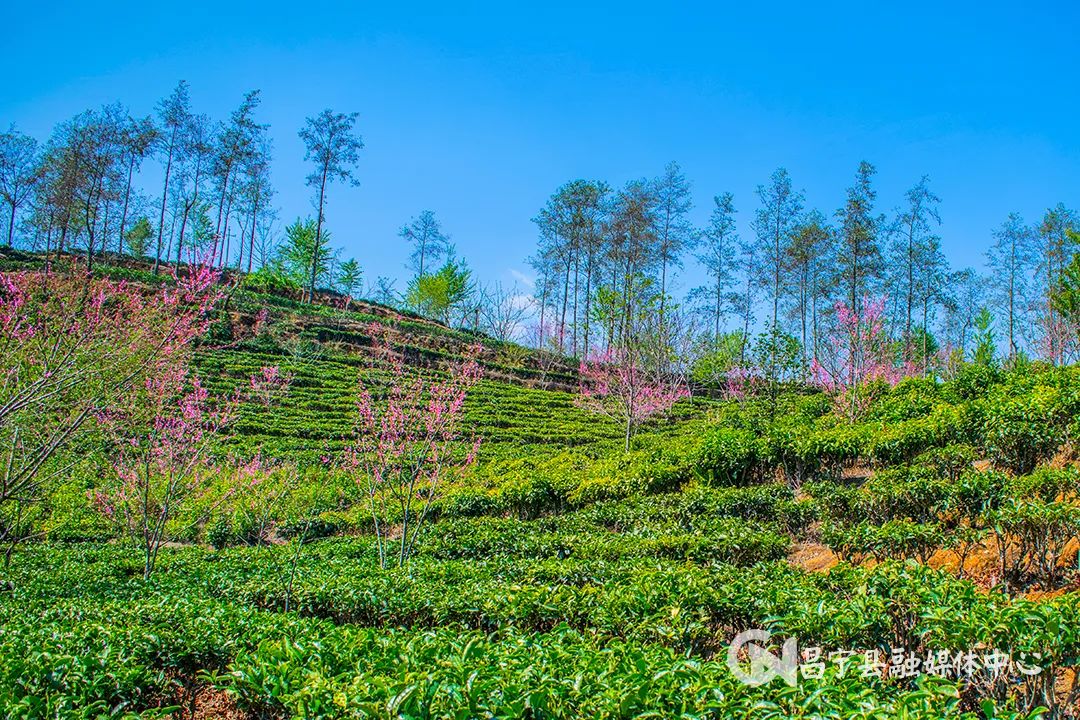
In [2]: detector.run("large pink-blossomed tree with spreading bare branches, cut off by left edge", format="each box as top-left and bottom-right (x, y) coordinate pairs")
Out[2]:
(0, 263), (221, 552)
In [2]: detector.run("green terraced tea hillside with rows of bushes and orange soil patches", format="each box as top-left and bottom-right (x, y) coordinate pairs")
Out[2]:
(0, 254), (1080, 720)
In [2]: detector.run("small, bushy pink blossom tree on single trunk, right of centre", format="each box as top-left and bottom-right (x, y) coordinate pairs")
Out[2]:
(578, 349), (689, 450)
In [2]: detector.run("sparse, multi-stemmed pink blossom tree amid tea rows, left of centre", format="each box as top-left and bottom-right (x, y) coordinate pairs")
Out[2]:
(345, 323), (481, 567)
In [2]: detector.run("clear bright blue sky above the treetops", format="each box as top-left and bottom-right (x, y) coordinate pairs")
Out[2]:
(0, 0), (1080, 295)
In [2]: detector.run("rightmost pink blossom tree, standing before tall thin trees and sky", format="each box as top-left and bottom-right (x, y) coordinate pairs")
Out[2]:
(810, 298), (915, 421)
